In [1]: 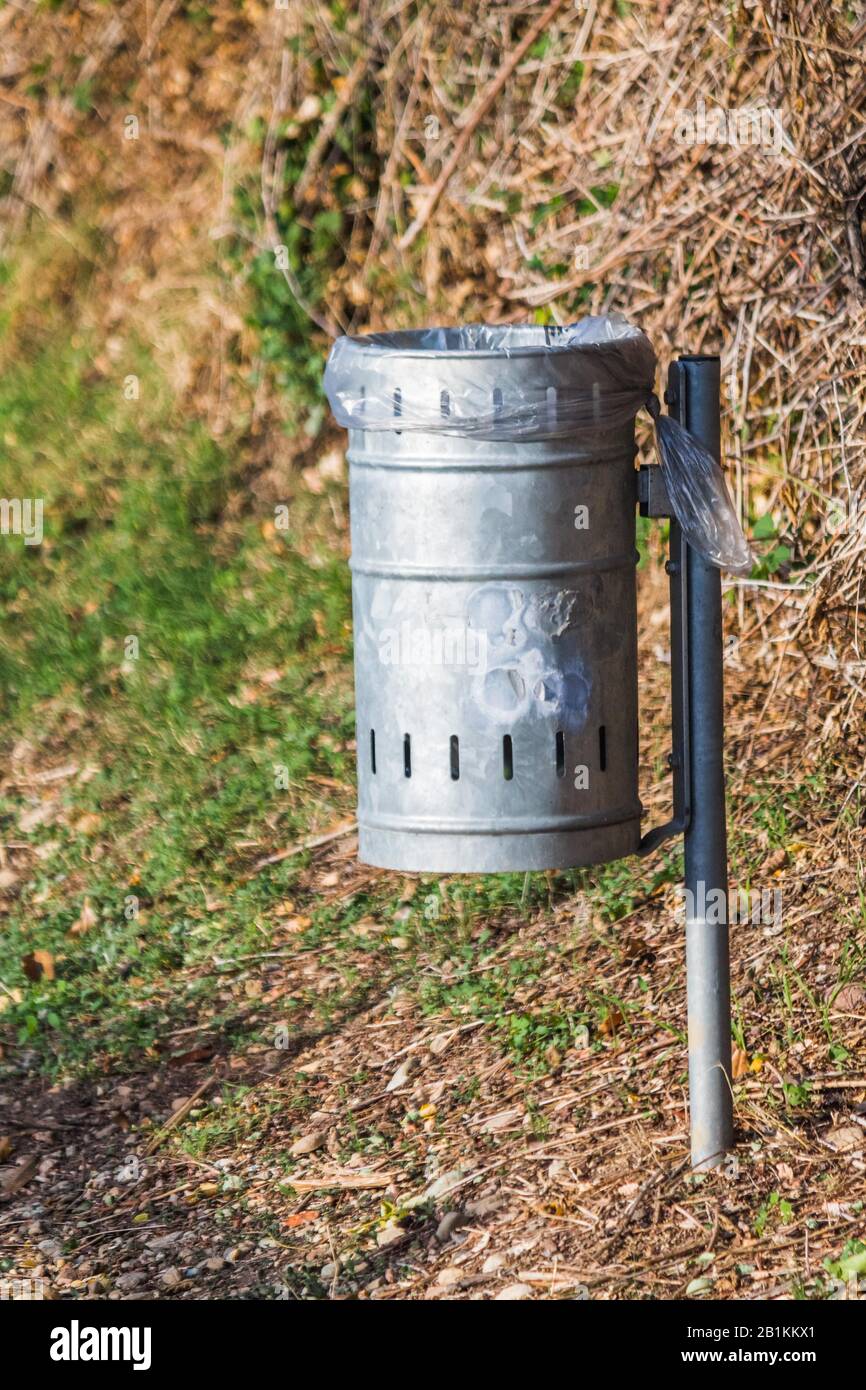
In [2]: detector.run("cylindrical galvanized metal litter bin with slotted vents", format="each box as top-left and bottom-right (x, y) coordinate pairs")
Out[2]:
(339, 328), (641, 872)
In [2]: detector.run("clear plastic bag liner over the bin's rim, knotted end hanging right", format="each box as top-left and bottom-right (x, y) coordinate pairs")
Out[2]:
(324, 314), (752, 574)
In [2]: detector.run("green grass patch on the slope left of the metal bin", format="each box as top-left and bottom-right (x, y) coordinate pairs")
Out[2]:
(0, 315), (353, 1066)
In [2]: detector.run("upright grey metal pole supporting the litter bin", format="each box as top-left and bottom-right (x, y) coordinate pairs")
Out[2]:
(666, 356), (734, 1169)
